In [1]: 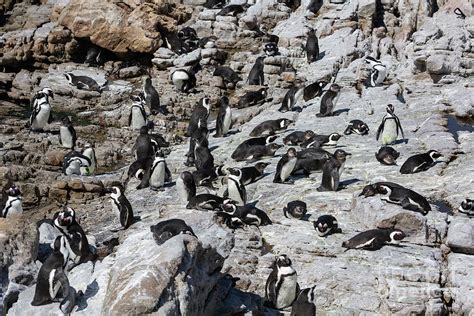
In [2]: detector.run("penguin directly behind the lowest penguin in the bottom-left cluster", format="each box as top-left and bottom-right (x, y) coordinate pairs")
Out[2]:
(53, 206), (96, 264)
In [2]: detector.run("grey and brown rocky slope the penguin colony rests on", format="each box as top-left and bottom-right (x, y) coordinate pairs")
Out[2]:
(0, 0), (474, 315)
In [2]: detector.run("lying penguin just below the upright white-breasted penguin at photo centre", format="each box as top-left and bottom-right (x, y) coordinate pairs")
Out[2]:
(218, 199), (272, 226)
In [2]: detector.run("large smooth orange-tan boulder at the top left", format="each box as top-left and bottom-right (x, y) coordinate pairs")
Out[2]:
(58, 0), (190, 54)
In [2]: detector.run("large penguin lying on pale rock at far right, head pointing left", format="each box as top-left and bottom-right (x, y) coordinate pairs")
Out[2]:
(360, 182), (431, 215)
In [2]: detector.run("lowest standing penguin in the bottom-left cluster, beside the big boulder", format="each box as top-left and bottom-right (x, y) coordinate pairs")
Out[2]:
(31, 236), (76, 315)
